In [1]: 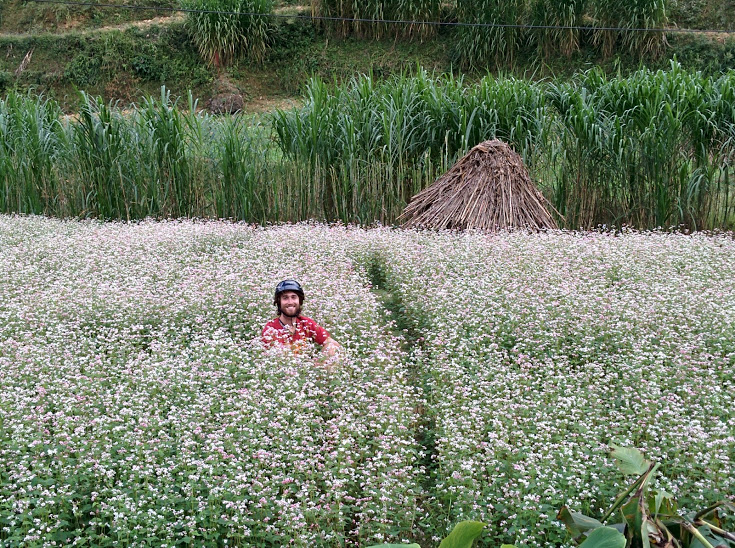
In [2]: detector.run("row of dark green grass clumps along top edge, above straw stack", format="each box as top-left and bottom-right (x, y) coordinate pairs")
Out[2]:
(316, 0), (668, 69)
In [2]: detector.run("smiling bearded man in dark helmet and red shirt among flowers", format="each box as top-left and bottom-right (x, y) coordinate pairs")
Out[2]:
(261, 280), (341, 358)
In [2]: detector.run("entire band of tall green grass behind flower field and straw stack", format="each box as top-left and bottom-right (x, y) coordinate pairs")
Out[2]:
(0, 63), (735, 229)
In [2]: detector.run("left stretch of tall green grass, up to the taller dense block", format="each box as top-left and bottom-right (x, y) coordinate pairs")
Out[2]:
(0, 90), (280, 222)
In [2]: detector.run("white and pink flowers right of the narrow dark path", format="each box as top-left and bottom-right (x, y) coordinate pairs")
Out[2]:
(380, 226), (735, 546)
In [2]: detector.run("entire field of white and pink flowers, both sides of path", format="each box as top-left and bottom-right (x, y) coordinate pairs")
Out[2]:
(0, 216), (735, 547)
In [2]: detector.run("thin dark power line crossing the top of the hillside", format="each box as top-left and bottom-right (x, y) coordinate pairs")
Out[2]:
(23, 0), (735, 34)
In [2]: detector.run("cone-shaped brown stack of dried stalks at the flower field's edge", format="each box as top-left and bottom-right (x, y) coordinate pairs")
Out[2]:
(398, 140), (557, 231)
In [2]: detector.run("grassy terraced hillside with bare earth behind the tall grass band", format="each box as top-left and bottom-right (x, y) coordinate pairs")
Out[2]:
(0, 0), (735, 111)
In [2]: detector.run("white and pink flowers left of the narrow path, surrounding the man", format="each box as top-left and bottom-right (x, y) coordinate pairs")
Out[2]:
(0, 217), (423, 546)
